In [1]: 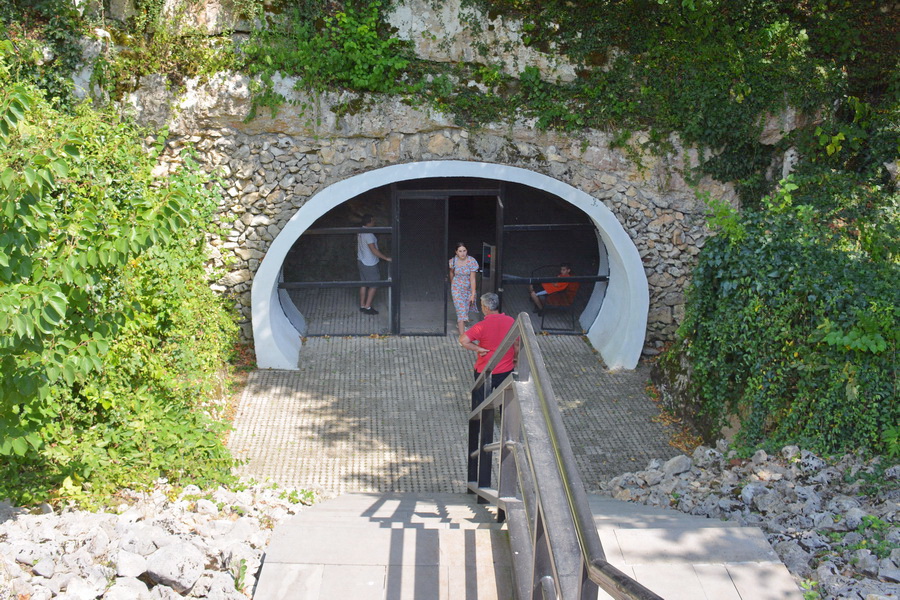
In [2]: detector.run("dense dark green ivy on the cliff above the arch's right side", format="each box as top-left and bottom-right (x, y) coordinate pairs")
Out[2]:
(466, 0), (864, 201)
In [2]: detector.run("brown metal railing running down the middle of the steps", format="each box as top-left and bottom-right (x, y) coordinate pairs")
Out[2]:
(468, 312), (662, 600)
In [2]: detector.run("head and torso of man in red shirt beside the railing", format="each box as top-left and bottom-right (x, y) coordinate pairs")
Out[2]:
(459, 292), (519, 409)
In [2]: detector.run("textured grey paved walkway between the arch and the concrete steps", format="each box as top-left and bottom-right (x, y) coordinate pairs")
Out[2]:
(229, 336), (678, 496)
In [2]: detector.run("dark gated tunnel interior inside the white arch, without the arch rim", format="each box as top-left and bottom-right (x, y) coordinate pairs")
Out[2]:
(279, 177), (608, 336)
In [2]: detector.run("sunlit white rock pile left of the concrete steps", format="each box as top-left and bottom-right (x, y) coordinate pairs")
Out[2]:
(0, 483), (302, 600)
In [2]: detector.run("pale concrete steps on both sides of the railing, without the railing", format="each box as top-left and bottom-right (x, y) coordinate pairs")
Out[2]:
(254, 494), (802, 600)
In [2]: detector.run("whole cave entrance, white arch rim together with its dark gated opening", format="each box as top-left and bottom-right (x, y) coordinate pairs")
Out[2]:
(250, 160), (650, 369)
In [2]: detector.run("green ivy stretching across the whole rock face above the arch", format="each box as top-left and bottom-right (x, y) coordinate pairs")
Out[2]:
(0, 0), (884, 202)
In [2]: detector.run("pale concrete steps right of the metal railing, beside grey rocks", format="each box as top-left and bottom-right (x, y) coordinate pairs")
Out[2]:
(589, 495), (803, 600)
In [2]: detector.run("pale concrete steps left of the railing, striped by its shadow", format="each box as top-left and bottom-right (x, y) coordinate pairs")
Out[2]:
(254, 494), (513, 600)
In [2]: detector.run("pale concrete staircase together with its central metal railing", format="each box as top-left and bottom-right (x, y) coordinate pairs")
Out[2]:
(255, 322), (802, 600)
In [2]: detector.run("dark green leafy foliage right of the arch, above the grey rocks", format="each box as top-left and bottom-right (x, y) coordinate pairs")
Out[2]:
(663, 91), (900, 454)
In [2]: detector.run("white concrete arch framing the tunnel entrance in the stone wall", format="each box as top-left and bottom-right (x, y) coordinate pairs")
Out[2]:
(251, 160), (650, 370)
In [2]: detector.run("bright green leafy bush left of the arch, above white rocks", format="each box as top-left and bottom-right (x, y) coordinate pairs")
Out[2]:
(0, 42), (235, 502)
